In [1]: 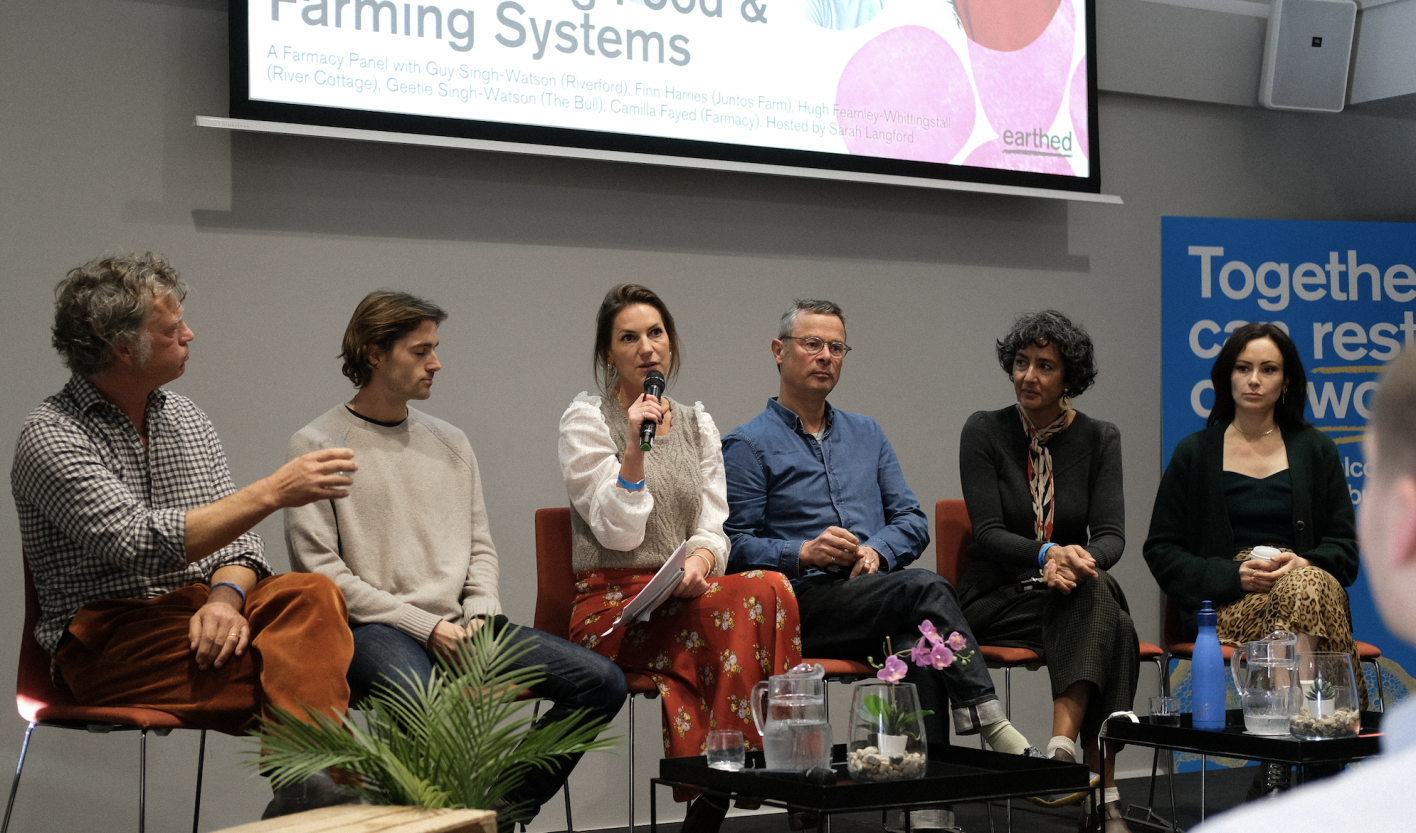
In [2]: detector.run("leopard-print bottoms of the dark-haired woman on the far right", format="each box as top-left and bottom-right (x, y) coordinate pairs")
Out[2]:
(1218, 550), (1368, 708)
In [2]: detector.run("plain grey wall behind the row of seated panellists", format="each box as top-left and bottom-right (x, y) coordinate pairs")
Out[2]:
(0, 0), (1416, 830)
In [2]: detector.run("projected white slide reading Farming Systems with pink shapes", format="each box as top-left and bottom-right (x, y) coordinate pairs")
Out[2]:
(246, 0), (1090, 179)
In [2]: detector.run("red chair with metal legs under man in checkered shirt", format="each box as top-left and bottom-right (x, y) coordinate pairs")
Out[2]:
(0, 558), (207, 833)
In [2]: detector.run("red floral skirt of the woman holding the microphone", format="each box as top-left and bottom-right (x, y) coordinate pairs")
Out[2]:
(571, 570), (801, 758)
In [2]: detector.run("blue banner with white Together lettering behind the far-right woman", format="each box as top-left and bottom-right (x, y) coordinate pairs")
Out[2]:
(1161, 217), (1416, 694)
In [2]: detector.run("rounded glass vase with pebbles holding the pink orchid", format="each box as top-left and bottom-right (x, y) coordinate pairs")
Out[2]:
(845, 680), (929, 782)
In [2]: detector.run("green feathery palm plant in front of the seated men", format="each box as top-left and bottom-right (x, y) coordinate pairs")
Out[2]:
(252, 617), (619, 809)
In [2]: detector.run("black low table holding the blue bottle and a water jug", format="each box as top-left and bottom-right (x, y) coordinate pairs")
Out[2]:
(1102, 708), (1382, 830)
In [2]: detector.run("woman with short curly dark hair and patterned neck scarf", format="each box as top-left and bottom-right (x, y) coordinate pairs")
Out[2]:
(959, 310), (1140, 833)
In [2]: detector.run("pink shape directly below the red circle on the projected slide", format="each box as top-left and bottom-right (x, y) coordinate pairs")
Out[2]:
(969, 0), (1076, 136)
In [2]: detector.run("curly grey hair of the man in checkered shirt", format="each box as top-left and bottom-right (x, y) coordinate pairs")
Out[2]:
(51, 252), (187, 377)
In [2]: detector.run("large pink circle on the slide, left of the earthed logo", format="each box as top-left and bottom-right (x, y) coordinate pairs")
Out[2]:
(835, 26), (974, 163)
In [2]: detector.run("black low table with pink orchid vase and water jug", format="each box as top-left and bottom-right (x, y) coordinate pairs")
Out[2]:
(649, 744), (1090, 833)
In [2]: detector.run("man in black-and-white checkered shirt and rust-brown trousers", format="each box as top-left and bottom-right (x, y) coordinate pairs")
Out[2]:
(10, 254), (357, 816)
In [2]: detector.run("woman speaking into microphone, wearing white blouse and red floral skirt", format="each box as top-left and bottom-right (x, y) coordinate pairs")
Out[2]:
(559, 283), (801, 833)
